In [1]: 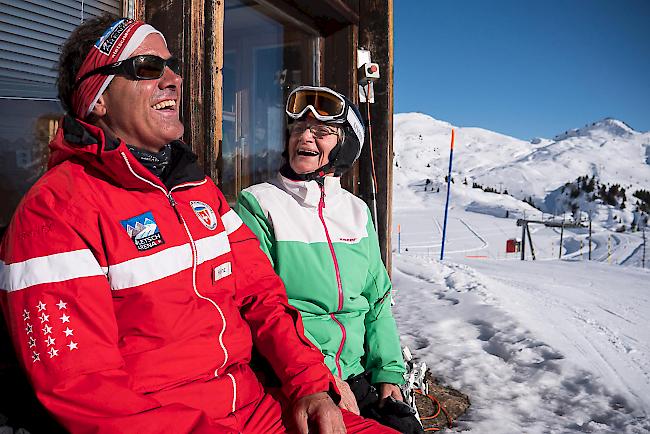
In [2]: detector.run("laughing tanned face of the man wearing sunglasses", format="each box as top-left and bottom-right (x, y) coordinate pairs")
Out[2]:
(101, 34), (183, 152)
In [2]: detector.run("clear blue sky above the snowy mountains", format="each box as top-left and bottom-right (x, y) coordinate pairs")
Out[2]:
(393, 0), (650, 139)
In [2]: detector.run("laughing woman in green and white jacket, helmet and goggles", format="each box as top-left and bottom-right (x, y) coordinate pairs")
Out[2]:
(235, 86), (420, 432)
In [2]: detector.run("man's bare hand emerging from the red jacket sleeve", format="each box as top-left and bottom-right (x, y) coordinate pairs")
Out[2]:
(293, 392), (347, 434)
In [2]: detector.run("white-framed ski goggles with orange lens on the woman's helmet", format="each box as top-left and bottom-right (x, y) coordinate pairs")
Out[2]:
(285, 86), (346, 122)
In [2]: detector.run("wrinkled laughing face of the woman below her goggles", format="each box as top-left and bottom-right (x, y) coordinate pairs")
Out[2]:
(288, 118), (338, 174)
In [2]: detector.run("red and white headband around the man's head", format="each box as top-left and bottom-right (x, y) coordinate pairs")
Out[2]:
(72, 18), (166, 119)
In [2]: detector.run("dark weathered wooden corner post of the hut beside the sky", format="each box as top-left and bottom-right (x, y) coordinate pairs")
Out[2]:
(359, 0), (393, 270)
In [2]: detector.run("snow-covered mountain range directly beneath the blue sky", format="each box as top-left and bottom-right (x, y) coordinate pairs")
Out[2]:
(394, 113), (650, 231)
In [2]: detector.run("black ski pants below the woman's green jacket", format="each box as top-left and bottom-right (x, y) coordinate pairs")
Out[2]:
(346, 374), (424, 434)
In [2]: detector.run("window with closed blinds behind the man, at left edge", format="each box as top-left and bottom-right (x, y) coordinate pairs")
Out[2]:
(0, 0), (123, 230)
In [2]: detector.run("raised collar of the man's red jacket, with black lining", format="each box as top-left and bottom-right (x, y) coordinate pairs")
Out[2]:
(48, 116), (205, 190)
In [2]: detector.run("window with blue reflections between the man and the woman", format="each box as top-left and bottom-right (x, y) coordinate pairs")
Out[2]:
(220, 0), (317, 201)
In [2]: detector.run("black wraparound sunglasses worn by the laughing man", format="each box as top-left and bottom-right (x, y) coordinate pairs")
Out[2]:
(74, 54), (181, 87)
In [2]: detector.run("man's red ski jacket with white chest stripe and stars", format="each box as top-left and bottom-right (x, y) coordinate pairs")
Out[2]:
(0, 117), (336, 433)
